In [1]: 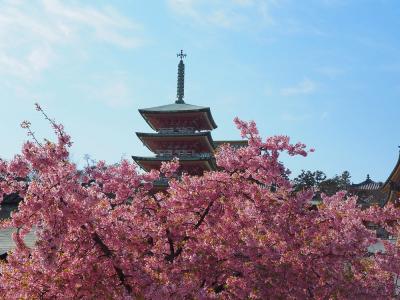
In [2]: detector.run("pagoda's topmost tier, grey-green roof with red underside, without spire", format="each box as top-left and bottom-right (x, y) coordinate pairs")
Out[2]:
(139, 103), (217, 131)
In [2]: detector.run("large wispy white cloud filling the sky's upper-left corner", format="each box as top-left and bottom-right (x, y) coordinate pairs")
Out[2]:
(0, 0), (143, 80)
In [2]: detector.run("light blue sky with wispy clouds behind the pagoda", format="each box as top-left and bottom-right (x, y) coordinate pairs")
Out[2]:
(0, 0), (400, 182)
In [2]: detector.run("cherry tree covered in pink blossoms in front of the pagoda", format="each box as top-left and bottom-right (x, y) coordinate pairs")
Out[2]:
(0, 105), (400, 299)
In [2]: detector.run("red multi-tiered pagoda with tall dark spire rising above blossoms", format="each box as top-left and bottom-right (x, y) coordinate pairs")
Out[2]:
(132, 50), (222, 185)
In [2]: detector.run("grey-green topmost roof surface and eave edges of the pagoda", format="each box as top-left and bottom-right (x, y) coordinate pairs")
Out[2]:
(139, 103), (217, 130)
